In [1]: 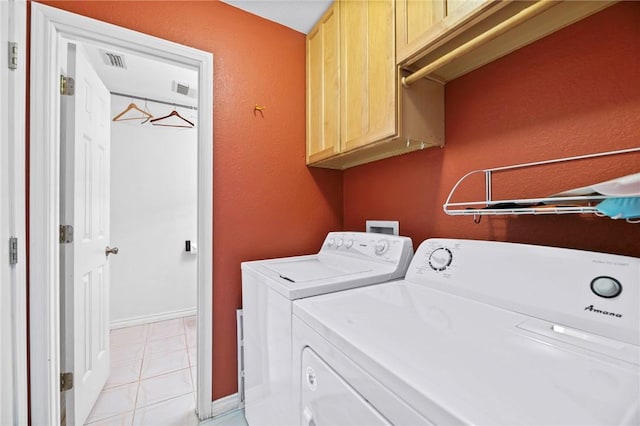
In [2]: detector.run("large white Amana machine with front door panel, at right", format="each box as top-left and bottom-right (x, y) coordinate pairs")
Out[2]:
(293, 239), (640, 426)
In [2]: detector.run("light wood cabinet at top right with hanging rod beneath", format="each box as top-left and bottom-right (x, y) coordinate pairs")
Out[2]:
(395, 0), (616, 83)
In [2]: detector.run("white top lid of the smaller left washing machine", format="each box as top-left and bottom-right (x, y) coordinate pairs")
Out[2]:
(265, 257), (373, 283)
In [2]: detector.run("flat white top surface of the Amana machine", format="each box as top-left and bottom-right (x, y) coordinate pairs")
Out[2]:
(294, 281), (640, 425)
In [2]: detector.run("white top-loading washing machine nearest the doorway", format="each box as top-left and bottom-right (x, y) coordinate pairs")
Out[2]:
(241, 232), (413, 426)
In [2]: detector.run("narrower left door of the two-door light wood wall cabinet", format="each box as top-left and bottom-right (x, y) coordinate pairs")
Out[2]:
(307, 3), (340, 164)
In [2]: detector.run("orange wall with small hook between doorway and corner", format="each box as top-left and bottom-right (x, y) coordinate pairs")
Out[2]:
(34, 1), (342, 398)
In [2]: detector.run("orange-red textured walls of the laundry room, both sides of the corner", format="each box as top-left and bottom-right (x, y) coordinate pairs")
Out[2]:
(31, 1), (640, 398)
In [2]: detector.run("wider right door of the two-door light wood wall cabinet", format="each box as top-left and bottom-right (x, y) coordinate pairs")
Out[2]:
(339, 0), (397, 152)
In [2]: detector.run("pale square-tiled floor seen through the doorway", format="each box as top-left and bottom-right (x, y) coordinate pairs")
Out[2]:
(86, 316), (198, 426)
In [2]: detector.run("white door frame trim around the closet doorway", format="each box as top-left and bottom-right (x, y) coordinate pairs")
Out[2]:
(29, 2), (213, 424)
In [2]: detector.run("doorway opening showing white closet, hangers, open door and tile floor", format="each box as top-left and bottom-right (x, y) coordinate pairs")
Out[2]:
(60, 40), (198, 424)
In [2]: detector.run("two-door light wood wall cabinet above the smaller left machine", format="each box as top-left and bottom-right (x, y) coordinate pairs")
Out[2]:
(307, 0), (444, 169)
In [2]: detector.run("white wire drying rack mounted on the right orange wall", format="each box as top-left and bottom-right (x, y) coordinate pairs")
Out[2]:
(442, 147), (640, 223)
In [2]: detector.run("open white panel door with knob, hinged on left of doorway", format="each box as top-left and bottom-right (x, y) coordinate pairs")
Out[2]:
(60, 43), (110, 425)
